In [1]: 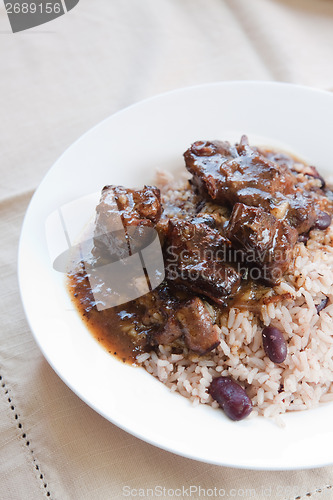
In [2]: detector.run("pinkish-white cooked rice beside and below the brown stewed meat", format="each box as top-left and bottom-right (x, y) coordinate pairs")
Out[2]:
(137, 170), (333, 425)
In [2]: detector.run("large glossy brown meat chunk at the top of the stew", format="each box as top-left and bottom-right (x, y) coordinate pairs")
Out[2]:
(184, 136), (295, 208)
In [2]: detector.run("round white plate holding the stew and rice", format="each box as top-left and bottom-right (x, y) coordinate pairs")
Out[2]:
(19, 82), (333, 469)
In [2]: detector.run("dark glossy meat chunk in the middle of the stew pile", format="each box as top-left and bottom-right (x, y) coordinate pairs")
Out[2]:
(164, 218), (241, 305)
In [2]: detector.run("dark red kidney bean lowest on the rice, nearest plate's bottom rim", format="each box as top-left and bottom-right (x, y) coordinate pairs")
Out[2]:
(209, 377), (252, 420)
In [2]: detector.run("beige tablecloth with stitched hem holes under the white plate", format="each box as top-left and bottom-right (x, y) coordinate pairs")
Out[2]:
(0, 0), (333, 500)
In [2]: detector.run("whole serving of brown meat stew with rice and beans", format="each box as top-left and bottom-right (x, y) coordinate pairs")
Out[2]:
(68, 136), (333, 420)
